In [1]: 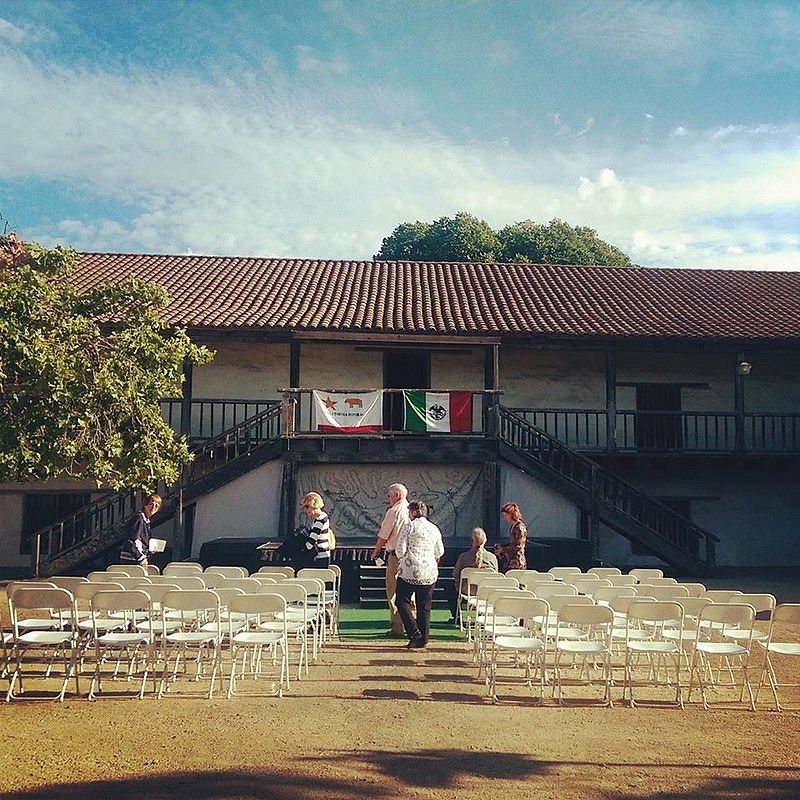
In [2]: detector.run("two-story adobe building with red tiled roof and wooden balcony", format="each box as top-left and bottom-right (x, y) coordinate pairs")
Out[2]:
(0, 253), (800, 572)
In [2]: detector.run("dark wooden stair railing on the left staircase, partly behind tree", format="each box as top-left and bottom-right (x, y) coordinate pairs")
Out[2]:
(31, 403), (281, 576)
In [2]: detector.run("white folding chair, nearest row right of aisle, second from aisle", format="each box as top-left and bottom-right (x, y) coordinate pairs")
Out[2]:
(553, 603), (614, 706)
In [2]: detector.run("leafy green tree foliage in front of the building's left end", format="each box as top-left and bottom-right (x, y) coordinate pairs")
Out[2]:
(0, 234), (213, 488)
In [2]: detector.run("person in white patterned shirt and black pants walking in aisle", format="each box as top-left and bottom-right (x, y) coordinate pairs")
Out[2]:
(395, 500), (444, 649)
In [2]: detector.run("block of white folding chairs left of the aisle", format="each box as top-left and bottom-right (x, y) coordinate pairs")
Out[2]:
(2, 576), (332, 700)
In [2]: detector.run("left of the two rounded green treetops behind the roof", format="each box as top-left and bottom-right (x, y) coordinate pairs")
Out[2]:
(375, 212), (499, 261)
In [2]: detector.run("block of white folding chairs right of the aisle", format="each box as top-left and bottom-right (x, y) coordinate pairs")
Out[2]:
(471, 578), (800, 710)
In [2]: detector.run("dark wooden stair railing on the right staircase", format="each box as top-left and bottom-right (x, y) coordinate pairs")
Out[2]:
(498, 406), (719, 571)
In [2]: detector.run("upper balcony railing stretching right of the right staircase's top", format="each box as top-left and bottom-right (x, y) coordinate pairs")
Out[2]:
(509, 408), (800, 453)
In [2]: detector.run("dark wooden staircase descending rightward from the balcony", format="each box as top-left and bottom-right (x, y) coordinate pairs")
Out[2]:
(497, 406), (719, 575)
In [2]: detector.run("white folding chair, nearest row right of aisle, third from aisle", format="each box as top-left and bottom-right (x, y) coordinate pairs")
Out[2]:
(622, 600), (683, 708)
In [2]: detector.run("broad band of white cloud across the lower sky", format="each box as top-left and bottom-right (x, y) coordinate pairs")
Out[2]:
(0, 50), (800, 269)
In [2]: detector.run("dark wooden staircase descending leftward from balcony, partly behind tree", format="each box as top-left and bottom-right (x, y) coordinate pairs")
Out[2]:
(31, 403), (282, 576)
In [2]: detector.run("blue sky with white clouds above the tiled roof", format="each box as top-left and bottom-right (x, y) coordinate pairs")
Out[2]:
(0, 0), (800, 270)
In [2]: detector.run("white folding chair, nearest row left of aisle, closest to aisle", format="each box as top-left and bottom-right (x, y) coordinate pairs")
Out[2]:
(228, 594), (289, 698)
